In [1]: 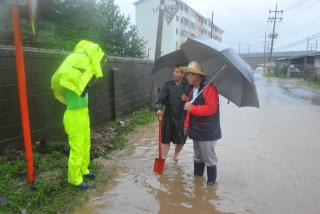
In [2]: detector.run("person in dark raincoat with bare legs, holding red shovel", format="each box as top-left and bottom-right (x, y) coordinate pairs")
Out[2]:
(156, 65), (190, 161)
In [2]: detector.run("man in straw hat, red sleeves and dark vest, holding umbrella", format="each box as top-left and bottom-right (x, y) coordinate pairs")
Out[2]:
(181, 61), (221, 185)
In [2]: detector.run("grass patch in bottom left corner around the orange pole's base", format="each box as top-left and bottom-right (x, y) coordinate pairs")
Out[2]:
(0, 151), (82, 213)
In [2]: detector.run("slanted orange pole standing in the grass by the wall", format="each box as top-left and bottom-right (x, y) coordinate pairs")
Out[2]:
(11, 5), (34, 183)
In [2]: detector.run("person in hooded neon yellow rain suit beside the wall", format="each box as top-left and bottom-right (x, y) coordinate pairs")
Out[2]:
(51, 40), (104, 189)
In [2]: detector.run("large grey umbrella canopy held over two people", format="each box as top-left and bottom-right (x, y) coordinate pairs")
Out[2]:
(153, 37), (259, 107)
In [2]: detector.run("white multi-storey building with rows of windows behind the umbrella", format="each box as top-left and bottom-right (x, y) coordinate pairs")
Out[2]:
(134, 0), (223, 59)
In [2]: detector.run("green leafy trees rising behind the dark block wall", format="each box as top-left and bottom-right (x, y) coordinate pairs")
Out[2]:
(20, 0), (144, 57)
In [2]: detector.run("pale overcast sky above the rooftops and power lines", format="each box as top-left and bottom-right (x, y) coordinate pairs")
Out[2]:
(115, 0), (320, 52)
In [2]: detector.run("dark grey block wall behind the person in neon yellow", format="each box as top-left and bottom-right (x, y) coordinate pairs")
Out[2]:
(0, 47), (153, 153)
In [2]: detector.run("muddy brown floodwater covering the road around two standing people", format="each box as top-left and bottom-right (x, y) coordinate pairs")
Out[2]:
(74, 74), (320, 214)
